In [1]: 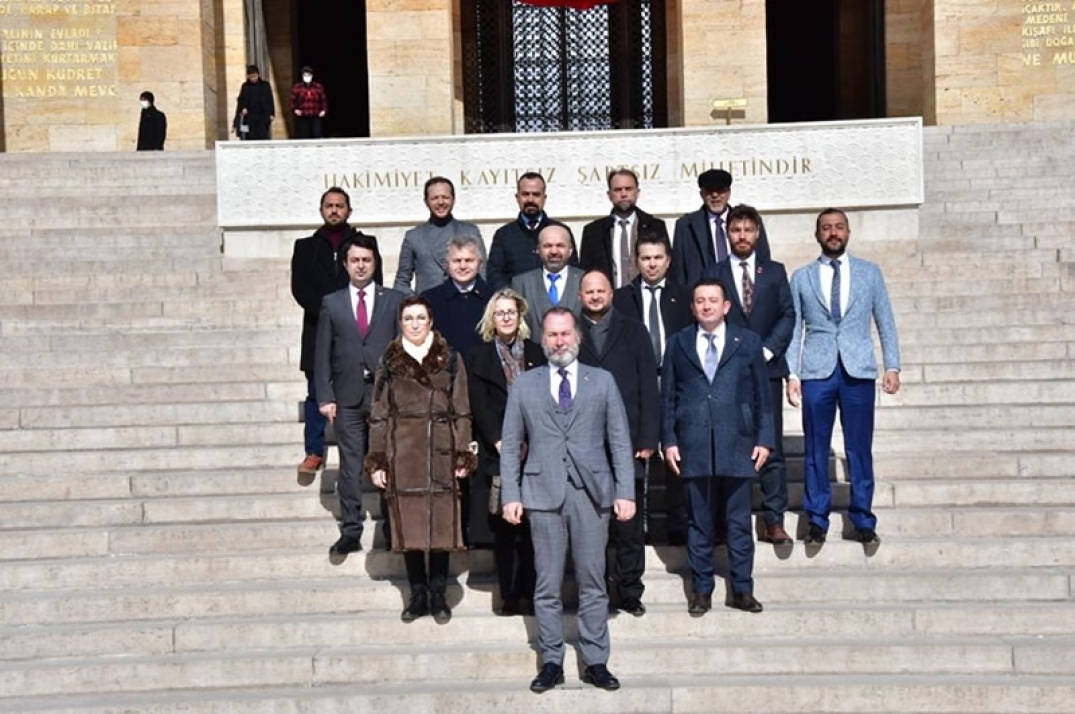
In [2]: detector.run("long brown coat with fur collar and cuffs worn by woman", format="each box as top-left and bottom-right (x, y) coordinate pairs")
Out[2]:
(364, 332), (477, 553)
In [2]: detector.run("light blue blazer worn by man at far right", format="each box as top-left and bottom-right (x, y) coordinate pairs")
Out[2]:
(787, 255), (900, 380)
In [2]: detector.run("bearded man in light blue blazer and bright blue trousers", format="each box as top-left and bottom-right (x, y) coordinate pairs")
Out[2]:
(787, 209), (900, 544)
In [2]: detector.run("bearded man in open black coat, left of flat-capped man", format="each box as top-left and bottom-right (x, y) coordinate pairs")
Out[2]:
(578, 169), (669, 288)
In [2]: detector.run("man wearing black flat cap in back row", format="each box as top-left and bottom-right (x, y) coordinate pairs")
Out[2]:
(670, 169), (771, 288)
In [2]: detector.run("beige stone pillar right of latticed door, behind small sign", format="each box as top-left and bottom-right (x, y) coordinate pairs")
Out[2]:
(669, 0), (769, 127)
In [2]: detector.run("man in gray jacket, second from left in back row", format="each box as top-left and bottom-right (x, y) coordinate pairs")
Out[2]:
(392, 176), (485, 295)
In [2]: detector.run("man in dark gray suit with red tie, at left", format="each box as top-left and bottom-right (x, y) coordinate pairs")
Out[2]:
(314, 233), (404, 558)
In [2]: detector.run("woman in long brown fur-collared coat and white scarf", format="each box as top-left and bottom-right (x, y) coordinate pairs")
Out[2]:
(366, 296), (477, 624)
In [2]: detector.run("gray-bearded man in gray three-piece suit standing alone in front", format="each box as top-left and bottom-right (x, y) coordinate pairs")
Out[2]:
(500, 306), (635, 692)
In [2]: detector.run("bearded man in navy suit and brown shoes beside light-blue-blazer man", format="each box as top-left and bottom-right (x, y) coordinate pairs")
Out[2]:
(714, 205), (796, 545)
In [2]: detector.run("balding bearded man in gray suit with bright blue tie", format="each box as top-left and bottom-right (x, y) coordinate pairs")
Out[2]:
(512, 225), (583, 342)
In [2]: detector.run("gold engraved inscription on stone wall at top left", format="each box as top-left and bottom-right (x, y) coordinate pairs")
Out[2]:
(0, 0), (117, 99)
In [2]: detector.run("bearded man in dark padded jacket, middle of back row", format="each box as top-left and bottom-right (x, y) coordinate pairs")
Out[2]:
(486, 171), (578, 290)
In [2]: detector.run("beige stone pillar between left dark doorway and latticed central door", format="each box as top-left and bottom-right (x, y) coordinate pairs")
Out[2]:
(366, 0), (455, 137)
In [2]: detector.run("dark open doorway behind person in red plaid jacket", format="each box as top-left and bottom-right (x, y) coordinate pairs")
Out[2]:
(291, 0), (370, 138)
